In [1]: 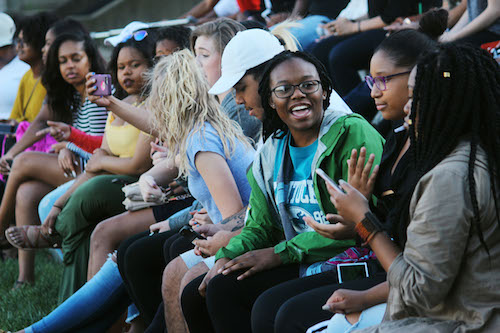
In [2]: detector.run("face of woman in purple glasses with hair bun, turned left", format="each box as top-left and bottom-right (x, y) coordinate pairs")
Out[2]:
(370, 51), (410, 120)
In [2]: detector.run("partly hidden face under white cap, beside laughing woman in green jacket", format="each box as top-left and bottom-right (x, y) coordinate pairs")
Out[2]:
(234, 74), (264, 121)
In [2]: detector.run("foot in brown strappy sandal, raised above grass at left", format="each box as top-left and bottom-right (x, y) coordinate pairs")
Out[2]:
(5, 225), (61, 250)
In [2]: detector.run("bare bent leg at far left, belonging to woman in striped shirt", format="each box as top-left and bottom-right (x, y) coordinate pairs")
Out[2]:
(0, 151), (75, 235)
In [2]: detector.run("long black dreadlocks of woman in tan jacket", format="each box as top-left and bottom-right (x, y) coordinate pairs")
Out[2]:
(403, 44), (500, 253)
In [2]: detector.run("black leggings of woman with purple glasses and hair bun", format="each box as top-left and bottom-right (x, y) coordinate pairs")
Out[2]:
(252, 271), (386, 333)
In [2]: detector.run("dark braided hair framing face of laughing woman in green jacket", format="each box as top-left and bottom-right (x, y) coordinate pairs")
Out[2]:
(259, 51), (333, 140)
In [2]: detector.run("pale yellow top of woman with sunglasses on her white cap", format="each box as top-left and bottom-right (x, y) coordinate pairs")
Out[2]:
(104, 112), (141, 157)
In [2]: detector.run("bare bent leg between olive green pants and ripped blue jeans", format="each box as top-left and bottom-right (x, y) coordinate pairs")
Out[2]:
(87, 208), (155, 280)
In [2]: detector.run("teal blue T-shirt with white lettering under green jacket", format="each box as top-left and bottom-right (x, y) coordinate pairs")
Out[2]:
(273, 134), (326, 234)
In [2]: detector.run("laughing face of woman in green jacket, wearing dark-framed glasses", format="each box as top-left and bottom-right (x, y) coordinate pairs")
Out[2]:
(269, 58), (326, 145)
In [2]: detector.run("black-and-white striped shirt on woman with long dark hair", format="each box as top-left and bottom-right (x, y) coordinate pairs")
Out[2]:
(73, 96), (108, 135)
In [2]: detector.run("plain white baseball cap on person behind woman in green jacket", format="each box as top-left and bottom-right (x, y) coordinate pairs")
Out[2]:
(208, 29), (285, 95)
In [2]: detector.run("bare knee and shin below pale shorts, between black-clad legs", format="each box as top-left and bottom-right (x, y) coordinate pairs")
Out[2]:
(161, 257), (188, 333)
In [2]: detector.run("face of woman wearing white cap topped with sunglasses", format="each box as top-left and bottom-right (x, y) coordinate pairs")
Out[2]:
(116, 47), (148, 95)
